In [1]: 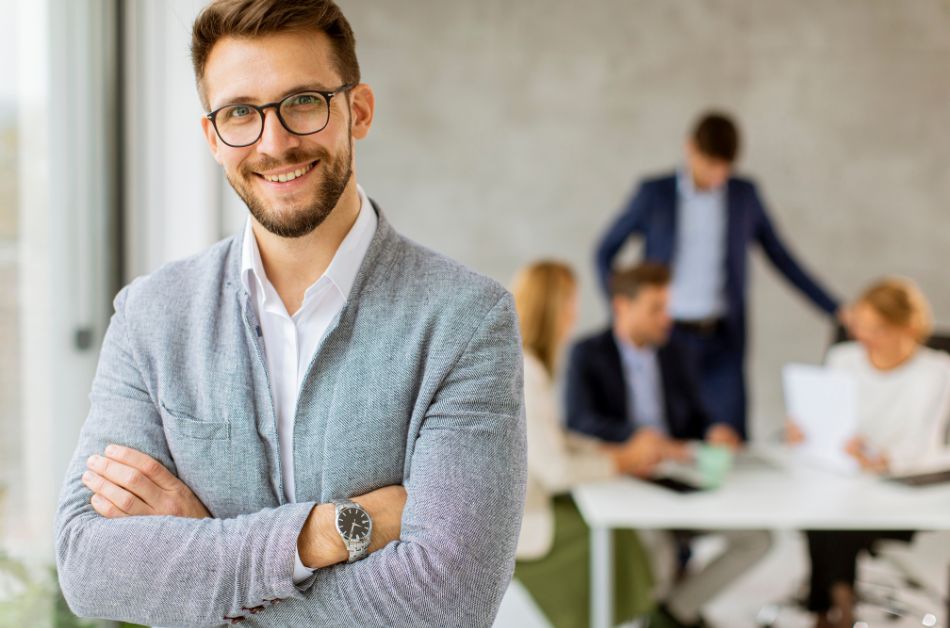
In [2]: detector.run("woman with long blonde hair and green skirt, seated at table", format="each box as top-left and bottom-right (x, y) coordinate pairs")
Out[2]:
(513, 261), (652, 628)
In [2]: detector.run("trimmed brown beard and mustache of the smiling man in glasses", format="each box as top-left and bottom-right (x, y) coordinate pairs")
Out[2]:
(227, 139), (353, 238)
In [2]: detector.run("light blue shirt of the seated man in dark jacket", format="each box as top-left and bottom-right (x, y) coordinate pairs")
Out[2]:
(614, 336), (668, 435)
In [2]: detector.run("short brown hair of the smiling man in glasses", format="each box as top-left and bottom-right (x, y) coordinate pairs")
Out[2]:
(191, 0), (360, 109)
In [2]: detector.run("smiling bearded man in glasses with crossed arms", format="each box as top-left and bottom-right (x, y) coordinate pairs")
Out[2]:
(56, 0), (525, 626)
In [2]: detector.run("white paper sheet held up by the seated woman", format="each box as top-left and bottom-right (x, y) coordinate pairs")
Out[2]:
(782, 364), (859, 473)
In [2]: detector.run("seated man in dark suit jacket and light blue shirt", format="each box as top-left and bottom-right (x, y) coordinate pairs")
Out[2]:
(567, 263), (771, 626)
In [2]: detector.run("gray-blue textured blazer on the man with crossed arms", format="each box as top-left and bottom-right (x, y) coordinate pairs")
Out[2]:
(55, 204), (525, 627)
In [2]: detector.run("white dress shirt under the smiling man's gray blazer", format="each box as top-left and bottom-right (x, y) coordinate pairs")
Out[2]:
(241, 187), (378, 582)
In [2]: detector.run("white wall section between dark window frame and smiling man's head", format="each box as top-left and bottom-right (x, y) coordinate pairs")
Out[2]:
(122, 0), (224, 281)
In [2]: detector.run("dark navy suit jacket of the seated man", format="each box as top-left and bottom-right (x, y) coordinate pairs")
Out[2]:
(566, 329), (710, 442)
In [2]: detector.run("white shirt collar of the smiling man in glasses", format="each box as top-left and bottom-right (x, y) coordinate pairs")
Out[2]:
(241, 185), (379, 303)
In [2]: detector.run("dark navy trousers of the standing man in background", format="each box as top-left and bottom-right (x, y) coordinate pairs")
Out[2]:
(671, 323), (747, 439)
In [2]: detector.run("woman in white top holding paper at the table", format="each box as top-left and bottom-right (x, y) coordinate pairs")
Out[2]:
(789, 278), (950, 628)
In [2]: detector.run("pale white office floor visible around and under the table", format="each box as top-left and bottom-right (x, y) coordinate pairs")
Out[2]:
(495, 533), (950, 628)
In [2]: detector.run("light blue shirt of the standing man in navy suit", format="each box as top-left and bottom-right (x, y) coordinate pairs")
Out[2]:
(670, 169), (727, 321)
